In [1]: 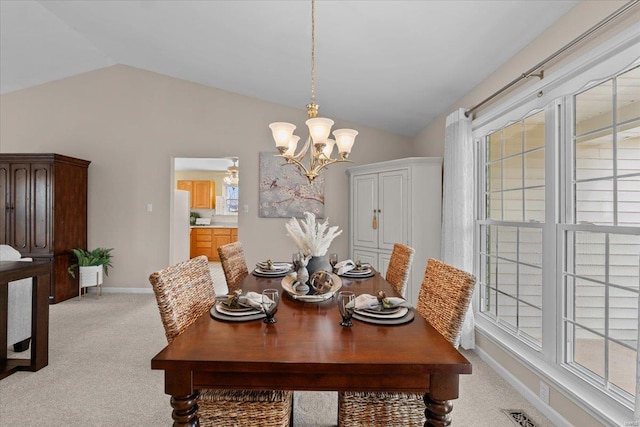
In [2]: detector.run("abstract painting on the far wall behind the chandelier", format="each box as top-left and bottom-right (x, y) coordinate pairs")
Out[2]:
(258, 152), (324, 218)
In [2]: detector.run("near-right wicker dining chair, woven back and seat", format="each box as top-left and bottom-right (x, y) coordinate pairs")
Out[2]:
(338, 259), (476, 427)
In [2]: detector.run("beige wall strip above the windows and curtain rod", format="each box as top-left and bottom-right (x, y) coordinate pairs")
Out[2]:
(415, 0), (640, 156)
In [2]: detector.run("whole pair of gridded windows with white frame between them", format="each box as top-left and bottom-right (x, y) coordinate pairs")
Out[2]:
(474, 60), (640, 416)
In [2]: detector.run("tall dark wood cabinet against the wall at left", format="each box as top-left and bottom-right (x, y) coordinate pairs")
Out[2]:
(0, 153), (91, 303)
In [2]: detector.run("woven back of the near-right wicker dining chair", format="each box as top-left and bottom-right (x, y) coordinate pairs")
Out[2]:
(416, 259), (476, 348)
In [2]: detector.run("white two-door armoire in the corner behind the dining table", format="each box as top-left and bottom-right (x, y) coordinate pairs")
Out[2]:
(347, 157), (442, 306)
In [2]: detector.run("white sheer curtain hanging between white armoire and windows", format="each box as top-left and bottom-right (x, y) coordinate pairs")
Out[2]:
(442, 108), (476, 349)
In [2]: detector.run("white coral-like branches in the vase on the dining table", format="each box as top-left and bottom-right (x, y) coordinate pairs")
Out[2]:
(285, 211), (342, 256)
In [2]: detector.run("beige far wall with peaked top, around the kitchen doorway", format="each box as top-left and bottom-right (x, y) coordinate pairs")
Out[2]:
(0, 65), (413, 288)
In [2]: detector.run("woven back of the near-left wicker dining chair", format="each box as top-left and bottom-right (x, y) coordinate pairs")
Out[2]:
(149, 255), (216, 343)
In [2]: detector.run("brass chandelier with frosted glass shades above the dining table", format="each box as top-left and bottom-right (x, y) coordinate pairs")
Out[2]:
(269, 0), (358, 184)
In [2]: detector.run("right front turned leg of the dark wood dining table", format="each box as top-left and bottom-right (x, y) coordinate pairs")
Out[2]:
(424, 374), (459, 427)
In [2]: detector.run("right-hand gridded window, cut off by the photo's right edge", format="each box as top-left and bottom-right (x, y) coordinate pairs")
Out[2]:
(562, 67), (640, 398)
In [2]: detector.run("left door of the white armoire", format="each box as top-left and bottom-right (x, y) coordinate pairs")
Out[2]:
(351, 173), (379, 249)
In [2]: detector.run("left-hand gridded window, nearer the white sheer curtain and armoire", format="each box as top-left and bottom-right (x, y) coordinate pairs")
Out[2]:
(479, 111), (545, 348)
